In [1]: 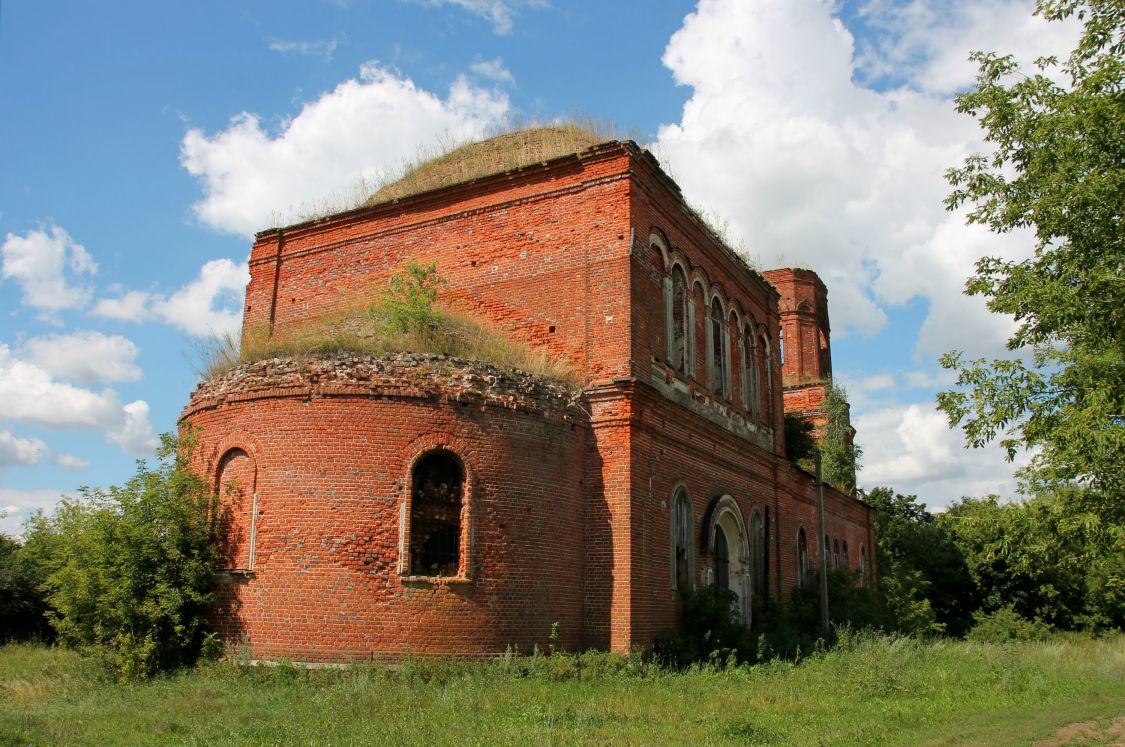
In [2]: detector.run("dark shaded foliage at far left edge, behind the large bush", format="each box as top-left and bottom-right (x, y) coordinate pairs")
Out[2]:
(0, 534), (52, 644)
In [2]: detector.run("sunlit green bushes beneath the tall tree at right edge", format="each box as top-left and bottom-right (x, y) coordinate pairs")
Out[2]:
(938, 487), (1125, 630)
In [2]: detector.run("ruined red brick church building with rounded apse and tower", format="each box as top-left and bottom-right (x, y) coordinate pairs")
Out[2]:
(182, 131), (874, 662)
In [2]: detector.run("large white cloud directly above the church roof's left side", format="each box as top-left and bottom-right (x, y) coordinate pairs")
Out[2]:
(180, 62), (510, 236)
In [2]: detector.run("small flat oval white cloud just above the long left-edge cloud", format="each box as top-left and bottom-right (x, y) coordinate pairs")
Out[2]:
(20, 331), (141, 384)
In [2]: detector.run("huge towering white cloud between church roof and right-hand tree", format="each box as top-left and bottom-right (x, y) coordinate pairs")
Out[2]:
(655, 0), (1071, 358)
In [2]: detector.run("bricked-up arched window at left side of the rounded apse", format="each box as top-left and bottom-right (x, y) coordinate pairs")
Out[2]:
(215, 449), (258, 570)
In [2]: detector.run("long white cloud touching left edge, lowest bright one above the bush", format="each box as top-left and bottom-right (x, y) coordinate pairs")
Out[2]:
(0, 343), (158, 454)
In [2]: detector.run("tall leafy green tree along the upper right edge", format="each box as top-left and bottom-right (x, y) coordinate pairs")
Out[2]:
(938, 0), (1125, 501)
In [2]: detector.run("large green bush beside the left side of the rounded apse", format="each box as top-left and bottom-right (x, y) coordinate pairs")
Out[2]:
(26, 435), (218, 680)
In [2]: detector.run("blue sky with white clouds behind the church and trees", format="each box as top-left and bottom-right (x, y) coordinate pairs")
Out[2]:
(0, 0), (1074, 532)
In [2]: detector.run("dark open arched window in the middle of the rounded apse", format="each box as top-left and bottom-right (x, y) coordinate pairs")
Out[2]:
(410, 451), (465, 576)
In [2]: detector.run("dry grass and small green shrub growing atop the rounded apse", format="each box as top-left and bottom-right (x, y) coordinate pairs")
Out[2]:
(196, 262), (577, 381)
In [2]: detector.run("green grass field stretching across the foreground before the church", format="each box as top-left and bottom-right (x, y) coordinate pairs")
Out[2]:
(0, 635), (1125, 745)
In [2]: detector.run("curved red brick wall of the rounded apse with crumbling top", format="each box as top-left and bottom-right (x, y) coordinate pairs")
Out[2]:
(186, 361), (586, 660)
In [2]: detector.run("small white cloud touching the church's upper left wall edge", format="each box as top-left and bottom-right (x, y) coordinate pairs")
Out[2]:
(151, 259), (250, 336)
